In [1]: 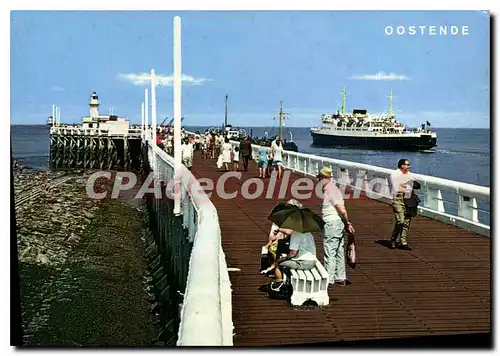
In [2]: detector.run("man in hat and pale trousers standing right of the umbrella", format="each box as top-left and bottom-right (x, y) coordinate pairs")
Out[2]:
(318, 167), (354, 287)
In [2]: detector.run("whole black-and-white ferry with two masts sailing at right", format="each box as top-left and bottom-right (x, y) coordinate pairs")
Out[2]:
(311, 88), (437, 151)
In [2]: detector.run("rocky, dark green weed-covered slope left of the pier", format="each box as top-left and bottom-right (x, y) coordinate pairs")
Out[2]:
(14, 162), (155, 346)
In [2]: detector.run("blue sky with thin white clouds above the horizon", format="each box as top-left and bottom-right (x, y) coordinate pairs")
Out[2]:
(10, 11), (490, 128)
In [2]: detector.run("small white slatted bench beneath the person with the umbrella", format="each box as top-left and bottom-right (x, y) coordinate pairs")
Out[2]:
(290, 260), (330, 306)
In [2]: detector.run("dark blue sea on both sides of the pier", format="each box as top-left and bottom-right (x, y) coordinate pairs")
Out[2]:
(11, 125), (491, 187)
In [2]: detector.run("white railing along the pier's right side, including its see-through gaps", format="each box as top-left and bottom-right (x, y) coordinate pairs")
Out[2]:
(231, 141), (491, 236)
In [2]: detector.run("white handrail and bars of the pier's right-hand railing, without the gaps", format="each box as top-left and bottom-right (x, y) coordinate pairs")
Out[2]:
(231, 141), (490, 236)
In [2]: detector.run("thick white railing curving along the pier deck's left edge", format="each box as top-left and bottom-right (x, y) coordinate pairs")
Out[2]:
(148, 141), (233, 346)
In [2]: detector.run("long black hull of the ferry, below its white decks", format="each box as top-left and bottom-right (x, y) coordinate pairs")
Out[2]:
(311, 131), (437, 151)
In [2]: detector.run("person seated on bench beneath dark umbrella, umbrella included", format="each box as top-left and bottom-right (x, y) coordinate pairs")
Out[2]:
(269, 204), (324, 282)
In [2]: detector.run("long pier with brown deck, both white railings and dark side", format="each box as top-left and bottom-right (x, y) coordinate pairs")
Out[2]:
(135, 18), (491, 346)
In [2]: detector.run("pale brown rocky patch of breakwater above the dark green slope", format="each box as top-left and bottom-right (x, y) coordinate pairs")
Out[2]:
(14, 165), (101, 267)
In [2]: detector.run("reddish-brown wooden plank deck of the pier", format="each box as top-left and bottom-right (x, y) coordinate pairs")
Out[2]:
(192, 153), (491, 346)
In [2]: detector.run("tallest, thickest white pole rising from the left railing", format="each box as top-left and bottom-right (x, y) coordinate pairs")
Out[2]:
(174, 16), (182, 215)
